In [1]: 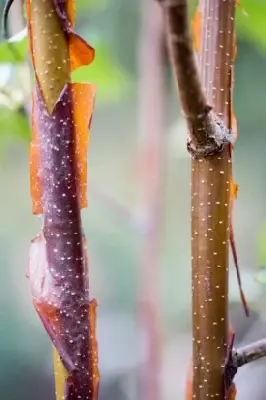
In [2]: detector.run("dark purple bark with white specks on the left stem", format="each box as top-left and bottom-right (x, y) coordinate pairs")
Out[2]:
(35, 85), (93, 400)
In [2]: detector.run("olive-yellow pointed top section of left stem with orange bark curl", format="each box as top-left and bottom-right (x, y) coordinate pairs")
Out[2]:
(26, 0), (94, 114)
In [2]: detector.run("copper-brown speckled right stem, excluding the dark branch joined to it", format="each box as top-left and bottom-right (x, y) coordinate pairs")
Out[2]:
(191, 0), (235, 400)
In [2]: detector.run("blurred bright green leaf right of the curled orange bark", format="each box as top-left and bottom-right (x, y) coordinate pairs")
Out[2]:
(71, 42), (131, 102)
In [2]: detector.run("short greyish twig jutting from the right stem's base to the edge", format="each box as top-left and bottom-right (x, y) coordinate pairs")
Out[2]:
(233, 339), (266, 368)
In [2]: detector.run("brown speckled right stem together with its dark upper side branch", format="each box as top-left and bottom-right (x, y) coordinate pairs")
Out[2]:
(160, 0), (235, 400)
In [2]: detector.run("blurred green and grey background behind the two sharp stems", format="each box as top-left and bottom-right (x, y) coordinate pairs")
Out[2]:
(0, 0), (266, 400)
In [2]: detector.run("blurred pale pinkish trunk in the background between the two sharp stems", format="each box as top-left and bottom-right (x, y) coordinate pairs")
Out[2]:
(138, 0), (166, 400)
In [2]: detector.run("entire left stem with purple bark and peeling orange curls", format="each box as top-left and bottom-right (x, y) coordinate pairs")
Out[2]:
(26, 0), (99, 400)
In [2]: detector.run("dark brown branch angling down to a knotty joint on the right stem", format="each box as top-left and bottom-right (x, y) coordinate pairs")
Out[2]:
(158, 0), (232, 158)
